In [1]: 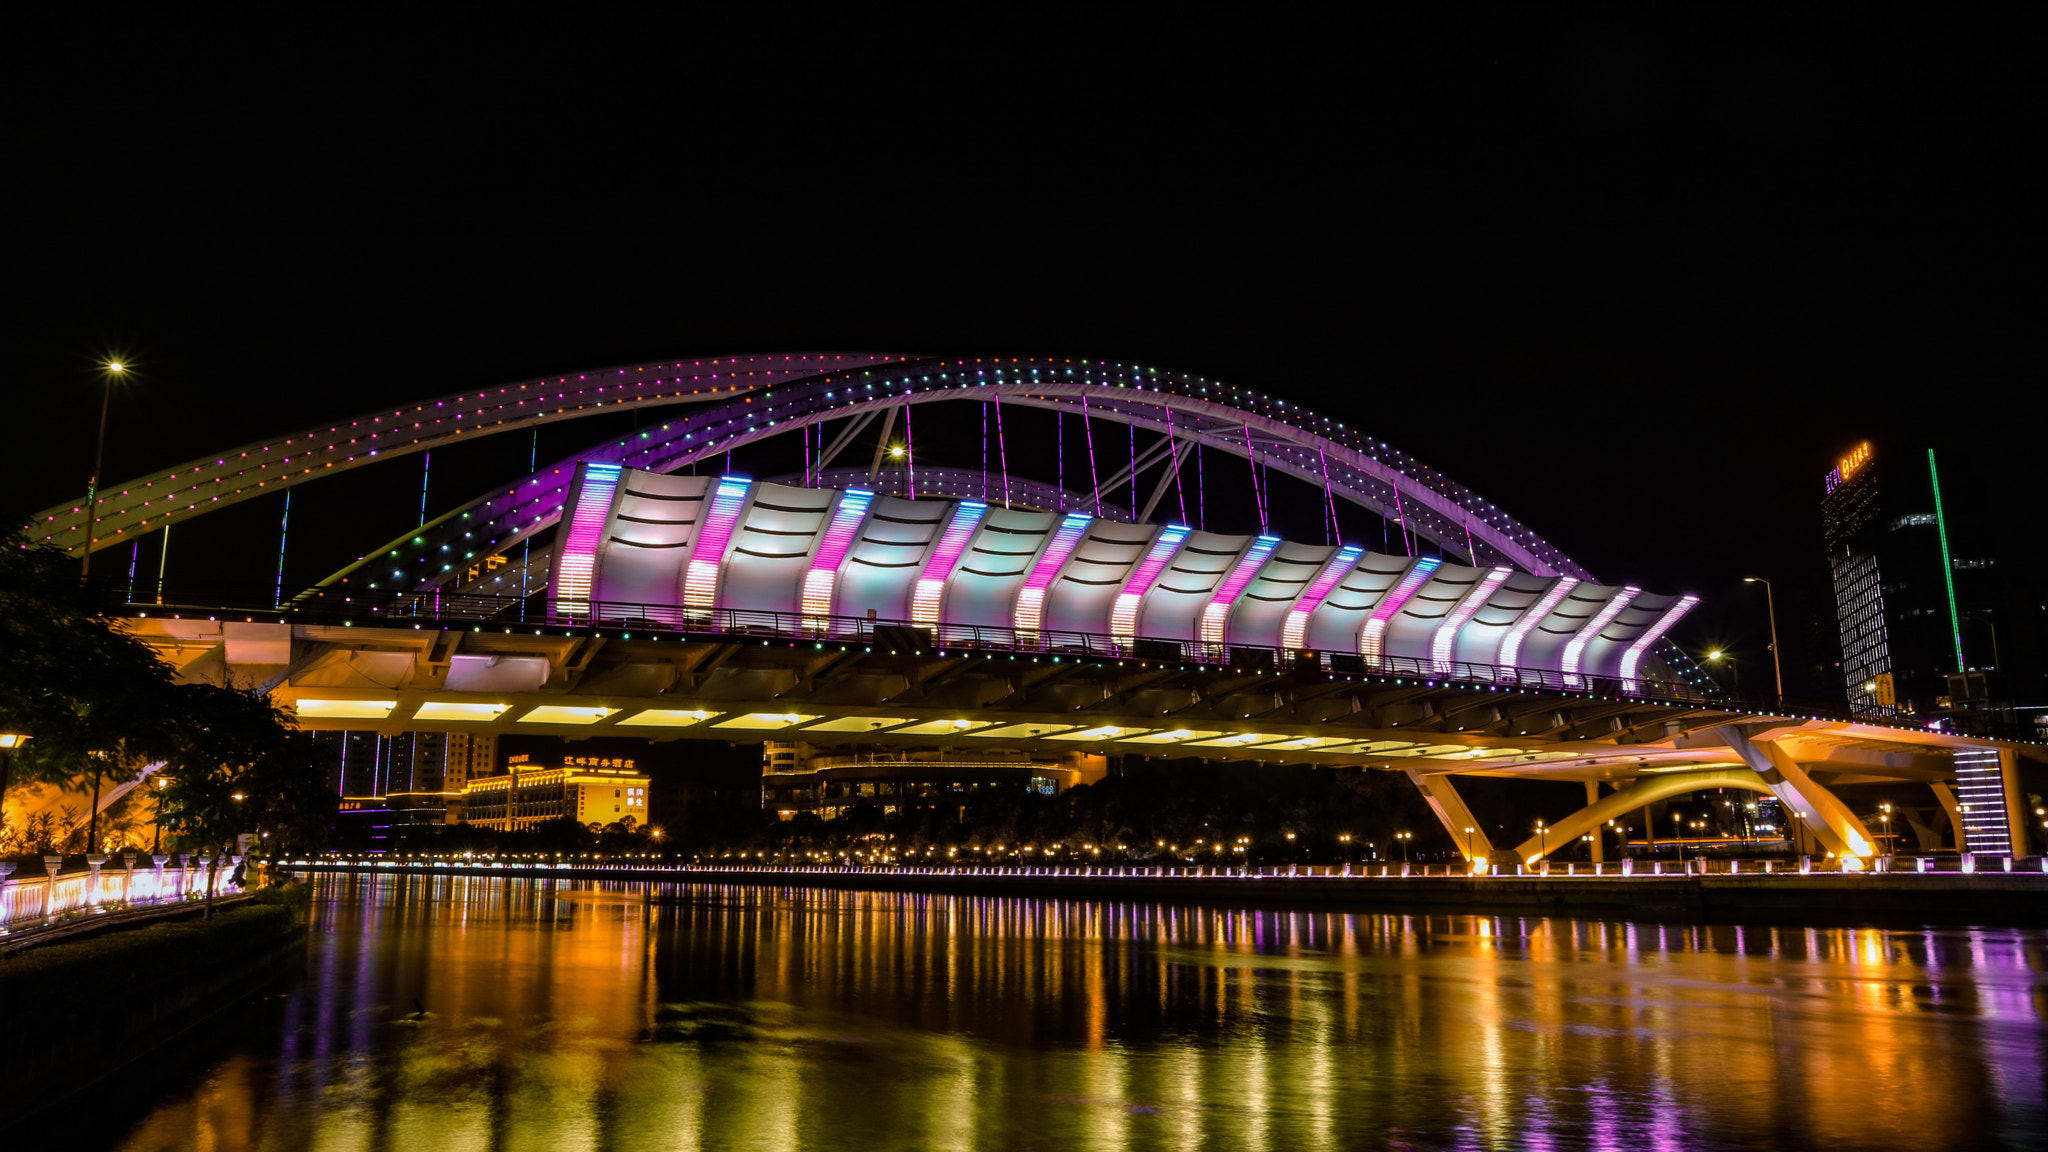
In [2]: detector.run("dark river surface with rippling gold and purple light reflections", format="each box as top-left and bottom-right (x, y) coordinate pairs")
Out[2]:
(92, 877), (2048, 1152)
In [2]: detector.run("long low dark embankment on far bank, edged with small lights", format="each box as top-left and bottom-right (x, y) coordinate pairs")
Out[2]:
(291, 863), (2048, 924)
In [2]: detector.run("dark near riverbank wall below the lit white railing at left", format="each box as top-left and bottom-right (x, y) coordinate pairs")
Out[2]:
(0, 890), (305, 1125)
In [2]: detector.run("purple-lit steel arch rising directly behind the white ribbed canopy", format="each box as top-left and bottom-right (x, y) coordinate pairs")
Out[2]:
(326, 357), (1593, 588)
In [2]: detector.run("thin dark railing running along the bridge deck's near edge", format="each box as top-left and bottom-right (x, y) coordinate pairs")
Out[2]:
(106, 584), (2030, 738)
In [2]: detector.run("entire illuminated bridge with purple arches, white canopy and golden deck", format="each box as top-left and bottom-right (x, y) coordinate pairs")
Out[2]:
(37, 353), (2042, 867)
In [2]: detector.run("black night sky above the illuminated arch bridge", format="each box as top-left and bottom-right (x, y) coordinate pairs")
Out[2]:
(0, 10), (2048, 695)
